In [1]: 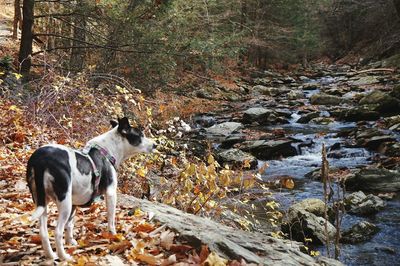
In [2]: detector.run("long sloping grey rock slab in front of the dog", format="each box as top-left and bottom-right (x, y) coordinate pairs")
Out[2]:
(118, 195), (340, 265)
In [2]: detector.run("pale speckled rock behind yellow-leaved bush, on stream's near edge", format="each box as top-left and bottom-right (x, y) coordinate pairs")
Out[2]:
(217, 149), (258, 169)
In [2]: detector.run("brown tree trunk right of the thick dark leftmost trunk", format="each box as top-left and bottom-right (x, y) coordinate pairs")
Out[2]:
(69, 0), (86, 72)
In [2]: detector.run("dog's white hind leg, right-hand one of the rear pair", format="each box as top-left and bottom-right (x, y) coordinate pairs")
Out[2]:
(54, 196), (72, 260)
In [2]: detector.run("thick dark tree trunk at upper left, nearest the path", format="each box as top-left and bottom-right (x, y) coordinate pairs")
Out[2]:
(19, 0), (35, 78)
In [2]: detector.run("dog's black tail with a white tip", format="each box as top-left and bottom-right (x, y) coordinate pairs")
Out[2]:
(26, 158), (46, 221)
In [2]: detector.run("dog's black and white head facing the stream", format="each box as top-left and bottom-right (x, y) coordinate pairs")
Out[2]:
(110, 117), (156, 156)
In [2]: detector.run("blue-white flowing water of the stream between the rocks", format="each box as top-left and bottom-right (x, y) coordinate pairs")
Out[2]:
(259, 77), (400, 265)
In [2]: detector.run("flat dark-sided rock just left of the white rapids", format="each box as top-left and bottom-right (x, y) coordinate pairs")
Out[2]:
(241, 139), (297, 160)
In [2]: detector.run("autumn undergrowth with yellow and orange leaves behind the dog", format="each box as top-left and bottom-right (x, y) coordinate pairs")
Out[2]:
(0, 69), (282, 230)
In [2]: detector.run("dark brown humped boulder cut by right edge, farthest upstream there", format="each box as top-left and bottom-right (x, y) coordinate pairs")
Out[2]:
(359, 90), (400, 113)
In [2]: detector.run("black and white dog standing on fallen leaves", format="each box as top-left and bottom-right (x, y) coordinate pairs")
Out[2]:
(26, 117), (155, 260)
